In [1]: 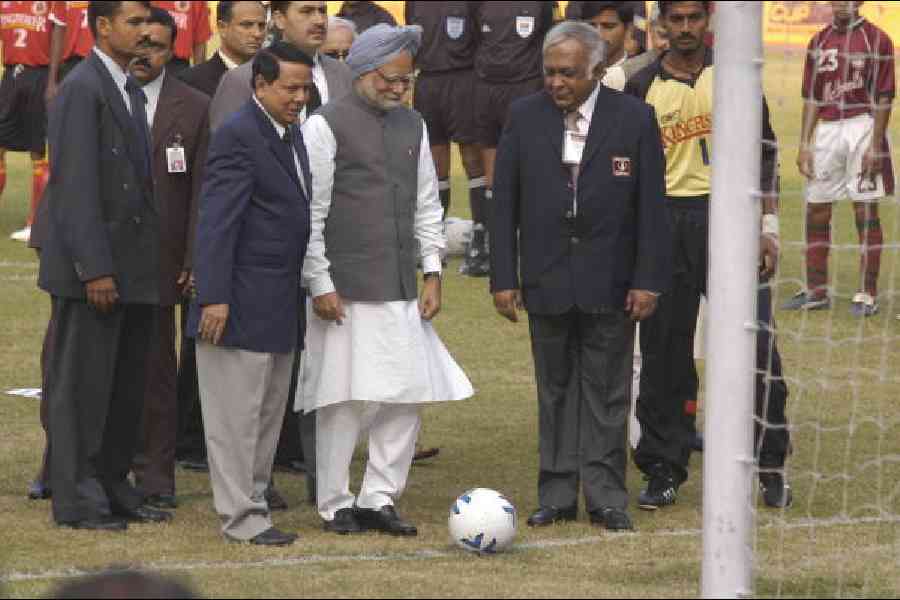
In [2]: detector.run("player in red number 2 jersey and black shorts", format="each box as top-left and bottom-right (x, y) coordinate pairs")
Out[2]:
(0, 2), (50, 241)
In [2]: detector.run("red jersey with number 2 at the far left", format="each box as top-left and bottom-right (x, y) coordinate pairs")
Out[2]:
(0, 2), (50, 67)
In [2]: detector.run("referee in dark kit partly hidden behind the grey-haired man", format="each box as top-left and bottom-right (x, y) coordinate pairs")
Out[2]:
(467, 2), (557, 275)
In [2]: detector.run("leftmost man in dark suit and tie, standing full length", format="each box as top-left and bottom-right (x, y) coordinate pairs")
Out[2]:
(39, 2), (171, 531)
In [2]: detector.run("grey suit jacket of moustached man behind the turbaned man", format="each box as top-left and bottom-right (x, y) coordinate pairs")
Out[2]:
(209, 54), (353, 131)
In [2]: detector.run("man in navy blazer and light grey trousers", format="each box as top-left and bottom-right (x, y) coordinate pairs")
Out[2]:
(188, 43), (313, 546)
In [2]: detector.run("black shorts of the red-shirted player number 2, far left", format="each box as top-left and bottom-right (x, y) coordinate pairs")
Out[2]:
(0, 65), (47, 154)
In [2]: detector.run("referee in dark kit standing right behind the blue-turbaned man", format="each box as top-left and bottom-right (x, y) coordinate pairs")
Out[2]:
(406, 2), (489, 277)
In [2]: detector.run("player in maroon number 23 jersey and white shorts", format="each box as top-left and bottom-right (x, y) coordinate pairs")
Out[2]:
(784, 2), (895, 317)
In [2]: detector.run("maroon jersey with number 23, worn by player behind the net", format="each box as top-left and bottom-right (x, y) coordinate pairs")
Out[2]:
(803, 19), (895, 121)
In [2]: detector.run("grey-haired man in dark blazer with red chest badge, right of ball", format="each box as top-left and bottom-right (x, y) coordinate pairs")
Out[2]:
(491, 21), (671, 529)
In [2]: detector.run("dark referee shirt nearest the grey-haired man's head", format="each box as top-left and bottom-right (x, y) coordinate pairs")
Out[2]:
(475, 0), (557, 83)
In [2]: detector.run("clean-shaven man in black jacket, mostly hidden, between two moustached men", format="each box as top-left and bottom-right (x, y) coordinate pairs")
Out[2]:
(178, 0), (266, 98)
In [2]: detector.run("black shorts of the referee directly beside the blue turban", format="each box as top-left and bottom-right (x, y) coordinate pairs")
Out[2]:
(414, 69), (478, 146)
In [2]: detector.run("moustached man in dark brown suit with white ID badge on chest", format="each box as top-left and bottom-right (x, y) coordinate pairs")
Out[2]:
(131, 7), (209, 508)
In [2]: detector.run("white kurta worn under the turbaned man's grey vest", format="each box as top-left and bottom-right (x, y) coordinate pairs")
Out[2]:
(295, 115), (474, 410)
